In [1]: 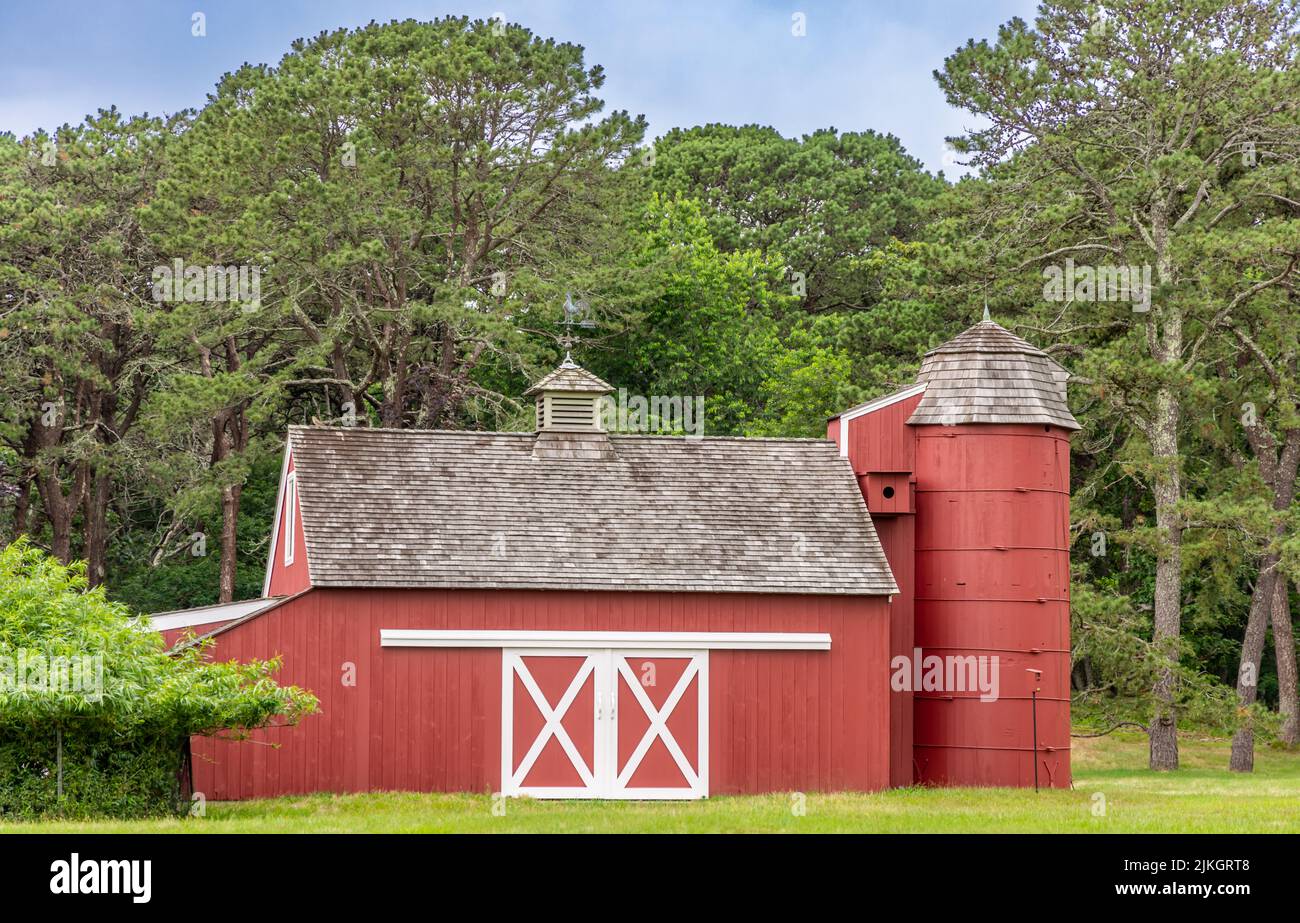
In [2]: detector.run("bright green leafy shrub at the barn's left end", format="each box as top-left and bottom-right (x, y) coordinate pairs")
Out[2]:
(0, 541), (316, 819)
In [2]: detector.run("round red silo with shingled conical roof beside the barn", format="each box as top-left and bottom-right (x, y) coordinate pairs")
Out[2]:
(907, 320), (1079, 788)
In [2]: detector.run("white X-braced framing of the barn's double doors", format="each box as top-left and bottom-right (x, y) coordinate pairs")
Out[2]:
(501, 647), (709, 801)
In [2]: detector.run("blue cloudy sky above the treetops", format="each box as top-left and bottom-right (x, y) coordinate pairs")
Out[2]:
(0, 0), (1035, 178)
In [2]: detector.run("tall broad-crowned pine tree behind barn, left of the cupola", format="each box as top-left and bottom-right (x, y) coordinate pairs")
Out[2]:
(154, 18), (644, 426)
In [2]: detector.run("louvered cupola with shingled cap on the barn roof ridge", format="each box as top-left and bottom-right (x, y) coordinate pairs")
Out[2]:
(524, 355), (614, 460)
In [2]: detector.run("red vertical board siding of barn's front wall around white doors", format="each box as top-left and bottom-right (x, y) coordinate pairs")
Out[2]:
(194, 588), (889, 800)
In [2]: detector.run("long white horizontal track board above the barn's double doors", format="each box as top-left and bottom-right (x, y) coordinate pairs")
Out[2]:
(380, 628), (831, 650)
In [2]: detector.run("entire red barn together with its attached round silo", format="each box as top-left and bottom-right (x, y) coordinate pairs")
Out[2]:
(156, 315), (1078, 800)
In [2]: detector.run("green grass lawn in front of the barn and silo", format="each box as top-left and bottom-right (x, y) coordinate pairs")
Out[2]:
(0, 733), (1300, 833)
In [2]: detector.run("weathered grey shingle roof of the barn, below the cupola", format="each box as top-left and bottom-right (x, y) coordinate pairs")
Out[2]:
(289, 426), (897, 595)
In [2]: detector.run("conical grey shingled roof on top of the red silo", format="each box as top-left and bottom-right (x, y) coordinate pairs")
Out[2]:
(907, 320), (1080, 429)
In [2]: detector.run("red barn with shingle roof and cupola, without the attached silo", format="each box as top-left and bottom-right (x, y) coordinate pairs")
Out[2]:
(178, 361), (898, 800)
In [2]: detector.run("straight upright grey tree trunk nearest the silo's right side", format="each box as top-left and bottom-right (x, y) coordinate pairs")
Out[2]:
(1151, 387), (1183, 770)
